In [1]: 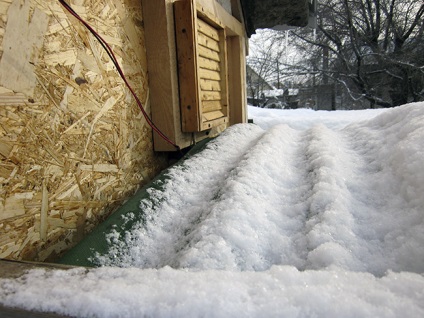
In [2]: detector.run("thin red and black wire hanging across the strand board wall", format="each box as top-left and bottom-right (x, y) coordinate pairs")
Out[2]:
(59, 0), (180, 150)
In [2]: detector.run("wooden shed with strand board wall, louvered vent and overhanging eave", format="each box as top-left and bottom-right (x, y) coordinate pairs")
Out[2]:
(0, 0), (309, 261)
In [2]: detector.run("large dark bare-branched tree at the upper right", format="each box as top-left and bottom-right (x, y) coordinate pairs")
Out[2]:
(292, 0), (424, 107)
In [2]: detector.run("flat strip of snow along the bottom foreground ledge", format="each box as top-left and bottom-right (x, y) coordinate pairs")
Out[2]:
(0, 266), (424, 317)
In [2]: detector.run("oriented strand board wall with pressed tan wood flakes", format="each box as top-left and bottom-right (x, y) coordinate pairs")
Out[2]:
(0, 0), (165, 260)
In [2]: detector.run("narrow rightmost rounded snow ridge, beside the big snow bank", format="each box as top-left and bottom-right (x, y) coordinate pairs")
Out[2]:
(302, 125), (365, 271)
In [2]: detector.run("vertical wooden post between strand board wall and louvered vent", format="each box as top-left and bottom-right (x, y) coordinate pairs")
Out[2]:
(142, 0), (181, 151)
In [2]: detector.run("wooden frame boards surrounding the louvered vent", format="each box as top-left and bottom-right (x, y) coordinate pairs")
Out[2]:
(142, 0), (247, 151)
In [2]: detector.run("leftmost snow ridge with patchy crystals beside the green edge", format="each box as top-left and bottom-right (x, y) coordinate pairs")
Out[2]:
(96, 125), (264, 268)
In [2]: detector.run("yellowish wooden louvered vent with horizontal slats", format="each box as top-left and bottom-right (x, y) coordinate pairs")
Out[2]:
(174, 0), (228, 132)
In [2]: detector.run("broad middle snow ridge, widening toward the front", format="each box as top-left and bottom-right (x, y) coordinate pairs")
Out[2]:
(171, 125), (308, 271)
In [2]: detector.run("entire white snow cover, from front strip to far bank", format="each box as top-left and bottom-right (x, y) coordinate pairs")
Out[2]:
(0, 103), (424, 317)
